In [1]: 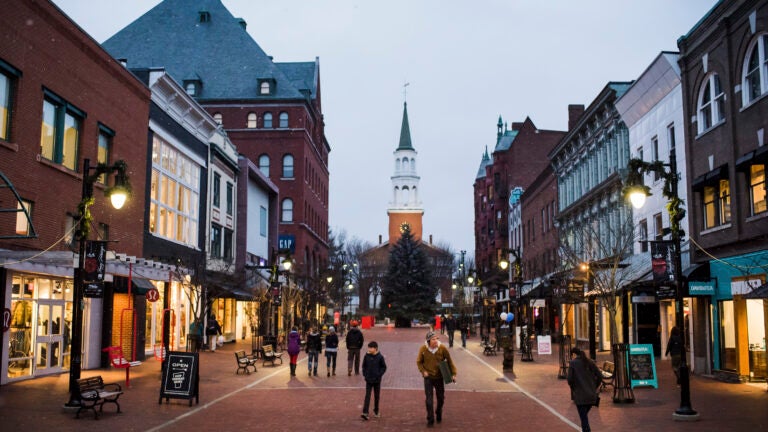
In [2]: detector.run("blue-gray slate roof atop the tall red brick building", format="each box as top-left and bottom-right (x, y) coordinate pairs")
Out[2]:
(103, 0), (318, 100)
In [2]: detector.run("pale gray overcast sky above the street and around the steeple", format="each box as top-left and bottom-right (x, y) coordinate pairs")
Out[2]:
(54, 0), (716, 256)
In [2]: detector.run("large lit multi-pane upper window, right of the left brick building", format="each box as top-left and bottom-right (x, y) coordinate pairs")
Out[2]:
(149, 135), (202, 247)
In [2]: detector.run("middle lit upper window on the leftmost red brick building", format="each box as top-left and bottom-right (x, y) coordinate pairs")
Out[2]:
(40, 92), (85, 171)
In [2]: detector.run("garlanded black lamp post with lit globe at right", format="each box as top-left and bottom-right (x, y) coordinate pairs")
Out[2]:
(624, 146), (699, 420)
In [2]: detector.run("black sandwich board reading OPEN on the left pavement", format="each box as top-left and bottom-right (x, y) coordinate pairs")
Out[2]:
(157, 351), (200, 406)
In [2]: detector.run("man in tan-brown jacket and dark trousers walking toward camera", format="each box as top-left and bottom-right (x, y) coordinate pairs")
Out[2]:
(416, 331), (456, 427)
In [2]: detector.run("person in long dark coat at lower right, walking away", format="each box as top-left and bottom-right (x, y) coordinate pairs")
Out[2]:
(568, 347), (603, 432)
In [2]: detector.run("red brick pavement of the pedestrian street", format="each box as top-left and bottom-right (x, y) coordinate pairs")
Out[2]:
(0, 327), (768, 432)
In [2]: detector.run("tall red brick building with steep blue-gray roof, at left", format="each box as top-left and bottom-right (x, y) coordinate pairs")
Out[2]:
(104, 0), (330, 283)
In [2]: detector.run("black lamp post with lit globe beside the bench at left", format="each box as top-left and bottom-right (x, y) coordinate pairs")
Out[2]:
(65, 159), (130, 407)
